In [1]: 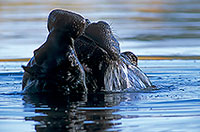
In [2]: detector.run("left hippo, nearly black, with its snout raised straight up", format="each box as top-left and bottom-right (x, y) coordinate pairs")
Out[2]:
(22, 9), (87, 94)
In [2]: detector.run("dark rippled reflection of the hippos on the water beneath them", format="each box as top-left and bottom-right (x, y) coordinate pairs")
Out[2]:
(23, 94), (121, 132)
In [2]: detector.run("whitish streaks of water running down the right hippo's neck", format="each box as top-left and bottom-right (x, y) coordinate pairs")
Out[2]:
(104, 57), (152, 92)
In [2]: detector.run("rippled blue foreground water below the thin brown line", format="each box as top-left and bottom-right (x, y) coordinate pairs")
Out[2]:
(0, 60), (200, 132)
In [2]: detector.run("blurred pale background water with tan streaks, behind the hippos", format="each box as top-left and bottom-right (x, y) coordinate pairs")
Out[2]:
(0, 0), (200, 58)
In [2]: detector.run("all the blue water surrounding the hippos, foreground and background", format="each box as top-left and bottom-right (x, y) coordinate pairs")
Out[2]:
(0, 0), (200, 132)
